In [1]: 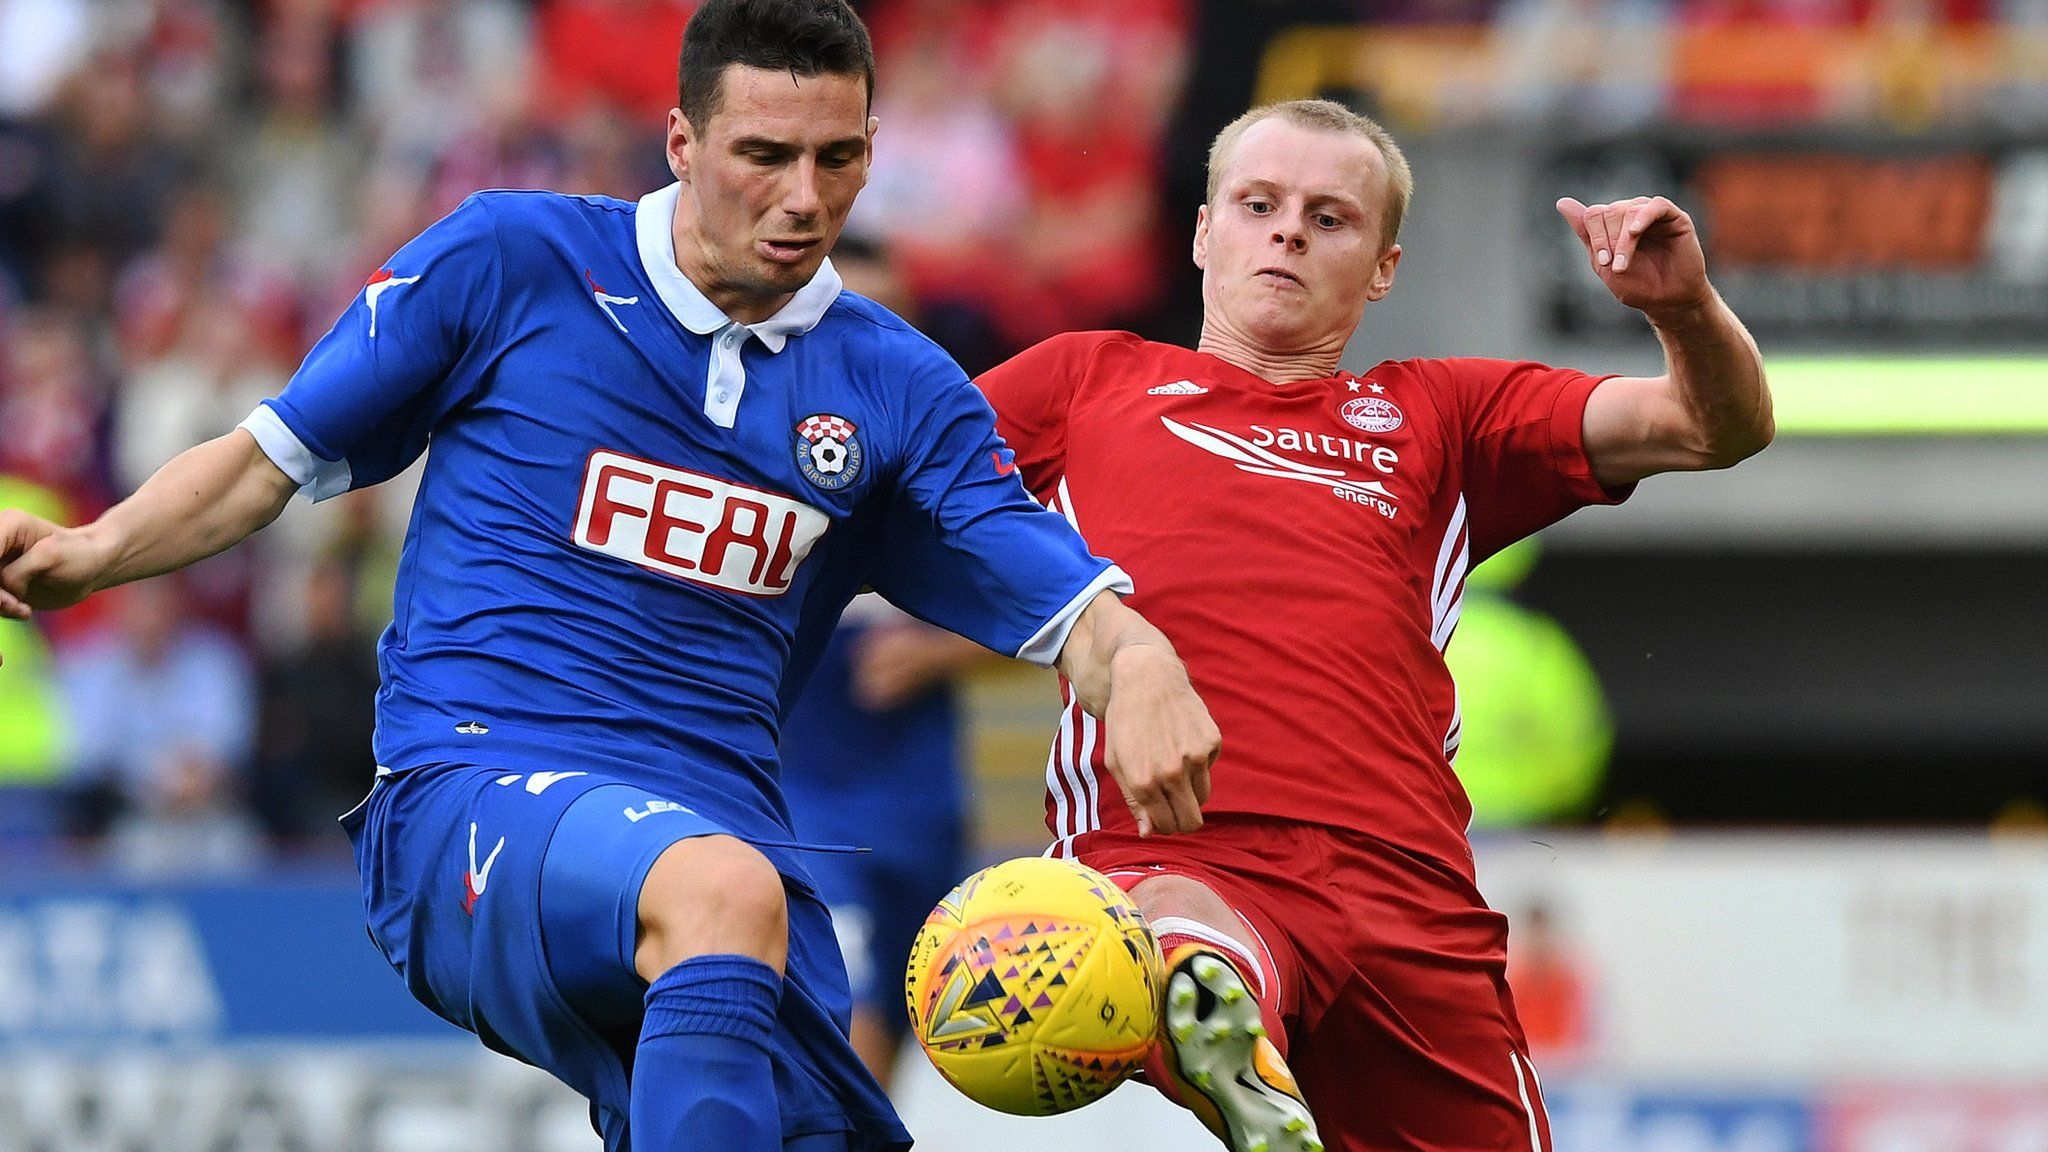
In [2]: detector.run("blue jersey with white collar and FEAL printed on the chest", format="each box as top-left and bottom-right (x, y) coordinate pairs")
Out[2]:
(244, 184), (1128, 865)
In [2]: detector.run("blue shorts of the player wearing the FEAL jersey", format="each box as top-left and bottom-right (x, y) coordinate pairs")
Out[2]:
(342, 767), (909, 1152)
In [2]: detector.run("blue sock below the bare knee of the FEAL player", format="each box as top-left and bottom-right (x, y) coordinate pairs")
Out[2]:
(629, 955), (782, 1152)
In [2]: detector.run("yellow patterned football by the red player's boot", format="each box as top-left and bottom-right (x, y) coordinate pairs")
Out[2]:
(905, 857), (1165, 1115)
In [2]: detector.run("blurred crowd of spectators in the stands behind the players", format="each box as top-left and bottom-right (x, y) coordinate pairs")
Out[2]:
(0, 0), (2048, 869)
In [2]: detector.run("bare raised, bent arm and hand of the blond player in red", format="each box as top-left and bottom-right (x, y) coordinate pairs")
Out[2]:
(1556, 197), (1776, 486)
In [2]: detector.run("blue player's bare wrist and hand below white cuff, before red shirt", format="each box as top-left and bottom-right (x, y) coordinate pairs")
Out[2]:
(1059, 592), (1223, 836)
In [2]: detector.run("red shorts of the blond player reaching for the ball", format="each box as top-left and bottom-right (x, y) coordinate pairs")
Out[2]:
(1075, 816), (1550, 1152)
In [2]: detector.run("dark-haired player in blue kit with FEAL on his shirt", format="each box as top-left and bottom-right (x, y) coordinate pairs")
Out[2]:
(0, 0), (1219, 1152)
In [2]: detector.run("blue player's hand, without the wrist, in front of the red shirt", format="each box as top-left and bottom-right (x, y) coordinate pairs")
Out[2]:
(1102, 644), (1223, 836)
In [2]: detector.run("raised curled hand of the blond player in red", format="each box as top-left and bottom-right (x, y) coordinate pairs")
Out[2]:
(1556, 197), (1714, 320)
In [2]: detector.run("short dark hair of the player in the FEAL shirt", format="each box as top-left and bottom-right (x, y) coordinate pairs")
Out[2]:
(676, 0), (874, 131)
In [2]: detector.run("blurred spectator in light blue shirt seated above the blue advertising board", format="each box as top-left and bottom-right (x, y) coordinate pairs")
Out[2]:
(59, 578), (260, 873)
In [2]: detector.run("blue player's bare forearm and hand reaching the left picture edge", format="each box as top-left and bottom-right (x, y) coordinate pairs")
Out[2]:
(0, 428), (299, 619)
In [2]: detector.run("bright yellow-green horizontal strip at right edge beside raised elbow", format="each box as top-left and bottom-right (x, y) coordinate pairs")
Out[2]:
(1765, 357), (2048, 437)
